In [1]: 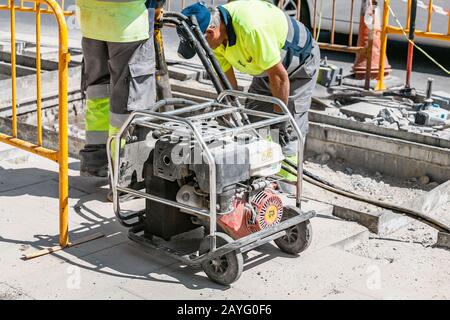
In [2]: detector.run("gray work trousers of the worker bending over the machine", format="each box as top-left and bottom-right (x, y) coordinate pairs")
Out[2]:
(245, 44), (320, 156)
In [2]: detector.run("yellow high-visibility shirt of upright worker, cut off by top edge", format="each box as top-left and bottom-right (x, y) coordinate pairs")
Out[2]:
(76, 0), (149, 42)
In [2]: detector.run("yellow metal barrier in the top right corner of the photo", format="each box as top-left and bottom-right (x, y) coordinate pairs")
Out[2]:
(376, 0), (450, 90)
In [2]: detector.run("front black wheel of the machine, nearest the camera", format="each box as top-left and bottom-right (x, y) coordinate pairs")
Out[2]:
(199, 232), (244, 286)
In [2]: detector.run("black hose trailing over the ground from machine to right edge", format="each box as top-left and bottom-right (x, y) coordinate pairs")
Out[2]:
(282, 160), (450, 232)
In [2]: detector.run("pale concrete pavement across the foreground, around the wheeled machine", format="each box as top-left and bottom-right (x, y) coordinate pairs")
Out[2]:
(0, 150), (450, 300)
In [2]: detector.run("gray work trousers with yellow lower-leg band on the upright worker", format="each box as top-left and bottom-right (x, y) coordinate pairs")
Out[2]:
(82, 37), (156, 145)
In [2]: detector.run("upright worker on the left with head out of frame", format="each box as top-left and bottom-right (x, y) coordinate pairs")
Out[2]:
(76, 0), (155, 177)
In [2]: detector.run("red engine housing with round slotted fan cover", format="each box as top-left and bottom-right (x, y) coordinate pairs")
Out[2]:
(218, 189), (283, 239)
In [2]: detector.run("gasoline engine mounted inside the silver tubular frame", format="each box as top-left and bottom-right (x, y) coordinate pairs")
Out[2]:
(121, 120), (284, 239)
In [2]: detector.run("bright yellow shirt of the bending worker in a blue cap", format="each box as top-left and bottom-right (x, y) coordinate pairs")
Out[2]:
(214, 0), (288, 76)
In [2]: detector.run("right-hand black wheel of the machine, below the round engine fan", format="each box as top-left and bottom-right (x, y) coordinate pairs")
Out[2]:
(275, 220), (312, 254)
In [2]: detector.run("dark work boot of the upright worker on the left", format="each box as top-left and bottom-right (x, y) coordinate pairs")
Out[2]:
(80, 144), (108, 178)
